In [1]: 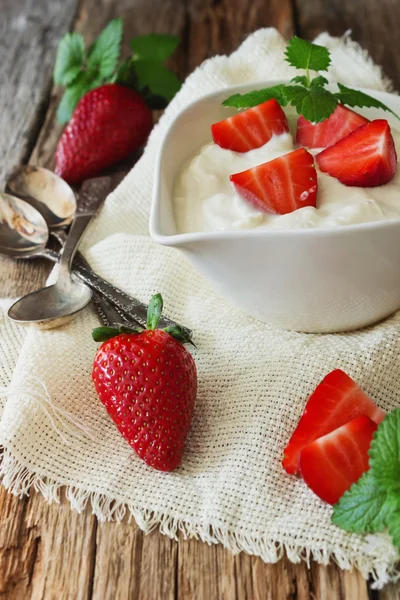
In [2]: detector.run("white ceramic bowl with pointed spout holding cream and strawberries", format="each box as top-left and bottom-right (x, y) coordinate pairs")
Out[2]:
(150, 81), (400, 333)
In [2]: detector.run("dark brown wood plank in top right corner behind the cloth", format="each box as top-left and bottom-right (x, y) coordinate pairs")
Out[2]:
(295, 0), (400, 90)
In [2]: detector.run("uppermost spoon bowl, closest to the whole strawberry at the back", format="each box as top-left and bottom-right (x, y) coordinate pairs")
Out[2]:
(7, 165), (77, 229)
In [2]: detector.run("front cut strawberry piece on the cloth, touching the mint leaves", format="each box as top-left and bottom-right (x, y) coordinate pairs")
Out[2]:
(299, 416), (378, 504)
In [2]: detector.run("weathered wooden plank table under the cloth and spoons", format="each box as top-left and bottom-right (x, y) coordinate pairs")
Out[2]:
(0, 0), (400, 600)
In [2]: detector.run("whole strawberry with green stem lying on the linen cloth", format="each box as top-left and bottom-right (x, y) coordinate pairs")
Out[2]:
(92, 294), (197, 471)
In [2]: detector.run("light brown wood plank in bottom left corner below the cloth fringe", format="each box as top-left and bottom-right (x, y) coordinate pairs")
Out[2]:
(0, 488), (97, 600)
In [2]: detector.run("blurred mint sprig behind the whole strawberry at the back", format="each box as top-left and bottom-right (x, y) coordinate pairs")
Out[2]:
(53, 18), (181, 123)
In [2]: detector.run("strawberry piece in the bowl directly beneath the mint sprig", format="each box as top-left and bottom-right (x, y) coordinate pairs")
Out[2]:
(296, 104), (369, 148)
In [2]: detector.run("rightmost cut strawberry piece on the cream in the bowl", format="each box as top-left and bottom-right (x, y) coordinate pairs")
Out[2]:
(316, 119), (397, 187)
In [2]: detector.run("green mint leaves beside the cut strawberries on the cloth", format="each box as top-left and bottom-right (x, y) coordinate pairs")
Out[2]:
(332, 408), (400, 550)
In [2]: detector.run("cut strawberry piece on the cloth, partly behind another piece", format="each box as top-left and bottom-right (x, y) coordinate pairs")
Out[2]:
(282, 369), (385, 474)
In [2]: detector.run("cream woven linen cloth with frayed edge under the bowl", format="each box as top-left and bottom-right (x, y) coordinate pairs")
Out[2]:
(0, 29), (400, 586)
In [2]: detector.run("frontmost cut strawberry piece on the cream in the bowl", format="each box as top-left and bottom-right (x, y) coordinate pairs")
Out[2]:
(230, 148), (318, 215)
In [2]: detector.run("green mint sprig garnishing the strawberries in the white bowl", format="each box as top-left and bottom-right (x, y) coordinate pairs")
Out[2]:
(223, 36), (400, 123)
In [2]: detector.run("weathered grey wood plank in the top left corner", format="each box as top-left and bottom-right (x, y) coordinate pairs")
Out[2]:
(0, 0), (78, 186)
